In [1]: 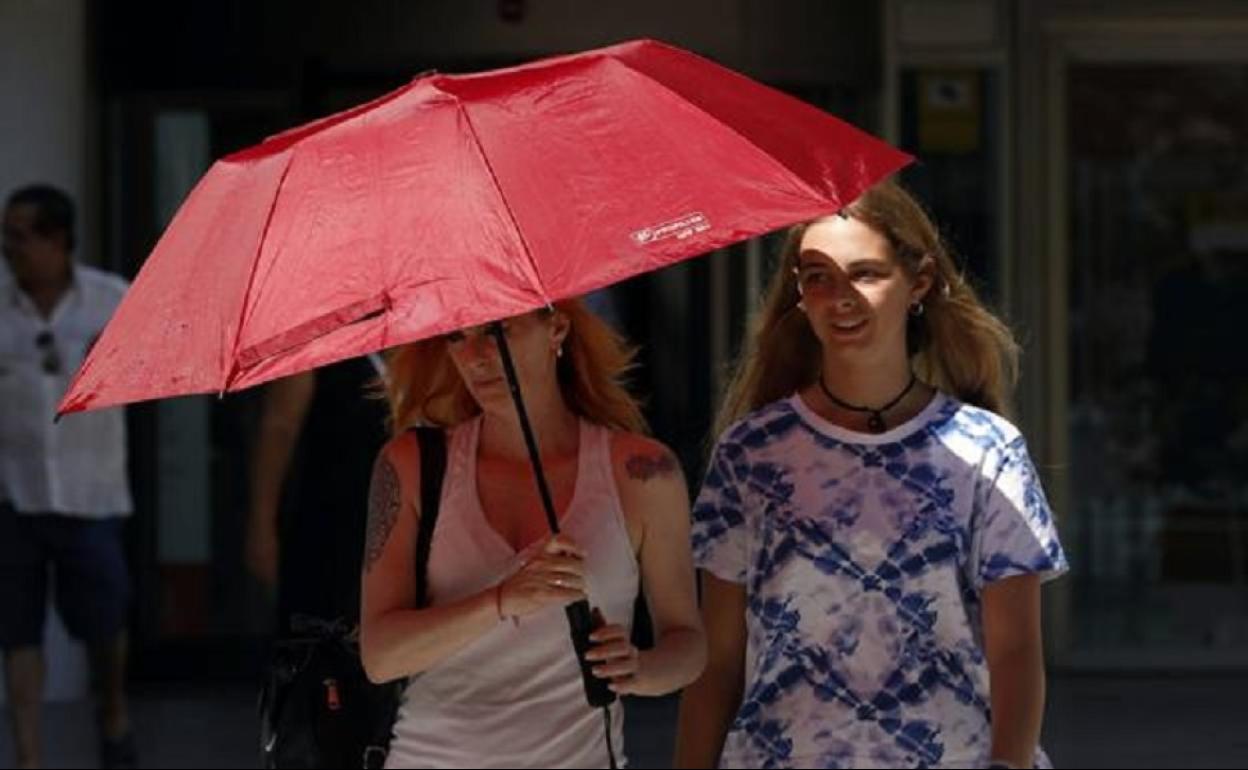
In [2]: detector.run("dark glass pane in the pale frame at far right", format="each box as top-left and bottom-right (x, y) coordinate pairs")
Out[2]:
(1065, 61), (1248, 665)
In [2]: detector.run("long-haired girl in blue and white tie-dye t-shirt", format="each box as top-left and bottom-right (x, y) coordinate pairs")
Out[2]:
(676, 181), (1066, 768)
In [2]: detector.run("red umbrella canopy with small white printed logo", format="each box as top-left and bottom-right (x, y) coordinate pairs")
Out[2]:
(60, 40), (910, 413)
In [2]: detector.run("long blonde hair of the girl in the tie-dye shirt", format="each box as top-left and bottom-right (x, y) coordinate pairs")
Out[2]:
(715, 180), (1018, 436)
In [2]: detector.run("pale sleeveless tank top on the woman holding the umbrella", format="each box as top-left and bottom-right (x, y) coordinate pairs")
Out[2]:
(386, 417), (639, 768)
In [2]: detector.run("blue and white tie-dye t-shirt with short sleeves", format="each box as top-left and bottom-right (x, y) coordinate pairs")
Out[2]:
(693, 393), (1066, 768)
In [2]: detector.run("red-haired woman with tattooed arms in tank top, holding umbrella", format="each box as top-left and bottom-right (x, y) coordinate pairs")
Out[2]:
(361, 300), (705, 768)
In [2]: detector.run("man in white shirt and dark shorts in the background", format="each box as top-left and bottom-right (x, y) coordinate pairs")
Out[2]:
(0, 185), (137, 768)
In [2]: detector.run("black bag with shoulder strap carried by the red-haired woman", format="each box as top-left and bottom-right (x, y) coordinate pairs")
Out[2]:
(260, 428), (447, 768)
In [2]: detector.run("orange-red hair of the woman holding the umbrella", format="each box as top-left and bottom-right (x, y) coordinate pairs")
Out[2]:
(384, 298), (648, 436)
